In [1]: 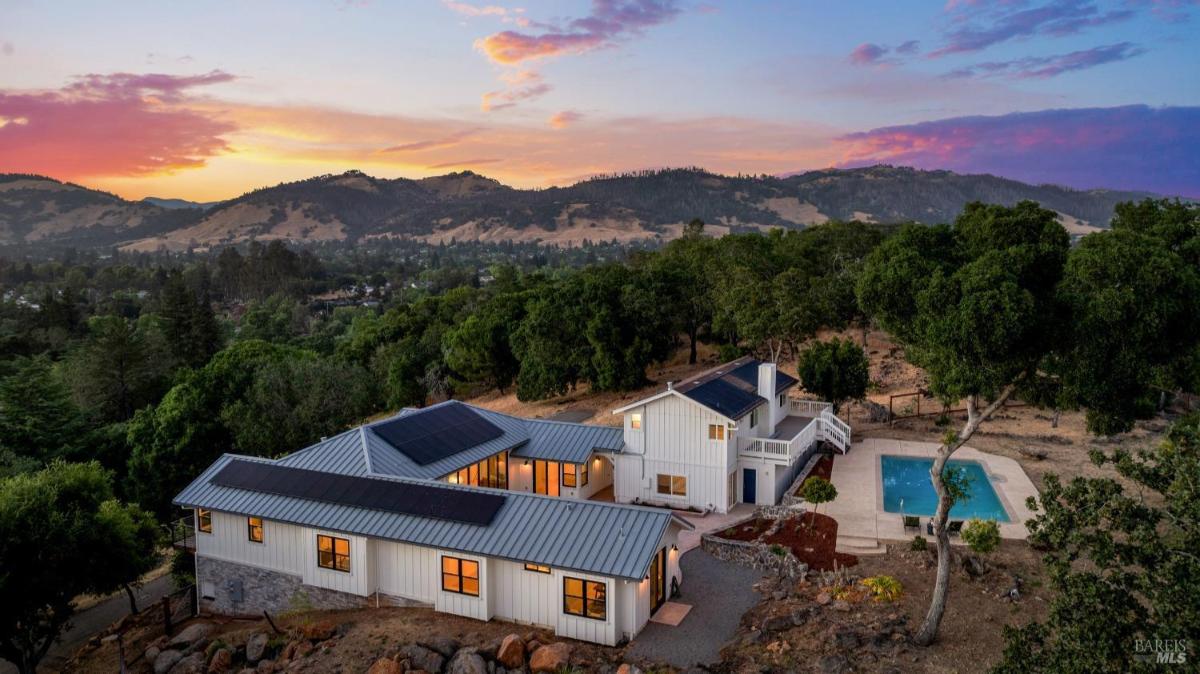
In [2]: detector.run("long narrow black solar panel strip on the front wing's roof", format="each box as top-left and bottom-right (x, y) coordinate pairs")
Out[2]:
(210, 459), (504, 525)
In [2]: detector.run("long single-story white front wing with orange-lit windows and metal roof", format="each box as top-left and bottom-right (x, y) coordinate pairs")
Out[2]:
(175, 455), (691, 645)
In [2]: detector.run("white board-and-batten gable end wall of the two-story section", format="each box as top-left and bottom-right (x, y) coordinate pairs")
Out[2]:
(613, 395), (737, 512)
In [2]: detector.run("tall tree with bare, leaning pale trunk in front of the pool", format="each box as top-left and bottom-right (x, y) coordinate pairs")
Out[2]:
(857, 201), (1200, 645)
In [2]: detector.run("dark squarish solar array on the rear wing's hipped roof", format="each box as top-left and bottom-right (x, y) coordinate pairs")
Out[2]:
(371, 402), (504, 465)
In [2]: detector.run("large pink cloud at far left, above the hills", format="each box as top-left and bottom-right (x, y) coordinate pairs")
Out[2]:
(0, 71), (235, 180)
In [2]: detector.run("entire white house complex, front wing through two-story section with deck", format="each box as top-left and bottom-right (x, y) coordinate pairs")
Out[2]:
(174, 359), (850, 644)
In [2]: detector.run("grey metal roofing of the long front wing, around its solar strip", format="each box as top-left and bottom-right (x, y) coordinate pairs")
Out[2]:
(173, 455), (692, 580)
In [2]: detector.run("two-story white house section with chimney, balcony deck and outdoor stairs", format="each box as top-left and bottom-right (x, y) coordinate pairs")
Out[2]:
(612, 357), (850, 512)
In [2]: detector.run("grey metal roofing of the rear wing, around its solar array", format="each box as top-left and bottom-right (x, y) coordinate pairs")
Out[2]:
(280, 401), (625, 480)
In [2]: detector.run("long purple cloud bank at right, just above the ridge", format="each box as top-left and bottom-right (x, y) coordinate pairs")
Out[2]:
(836, 106), (1200, 198)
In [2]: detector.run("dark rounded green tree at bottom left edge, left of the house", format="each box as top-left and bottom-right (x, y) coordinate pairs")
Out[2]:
(0, 462), (157, 674)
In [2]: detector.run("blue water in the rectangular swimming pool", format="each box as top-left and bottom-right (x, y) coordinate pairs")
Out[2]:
(880, 456), (1008, 522)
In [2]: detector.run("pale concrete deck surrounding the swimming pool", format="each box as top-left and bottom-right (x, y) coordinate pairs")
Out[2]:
(821, 438), (1038, 552)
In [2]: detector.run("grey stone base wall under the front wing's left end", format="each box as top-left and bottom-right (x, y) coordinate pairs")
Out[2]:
(196, 555), (373, 615)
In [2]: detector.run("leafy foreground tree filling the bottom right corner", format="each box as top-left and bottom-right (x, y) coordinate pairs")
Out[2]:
(994, 415), (1200, 674)
